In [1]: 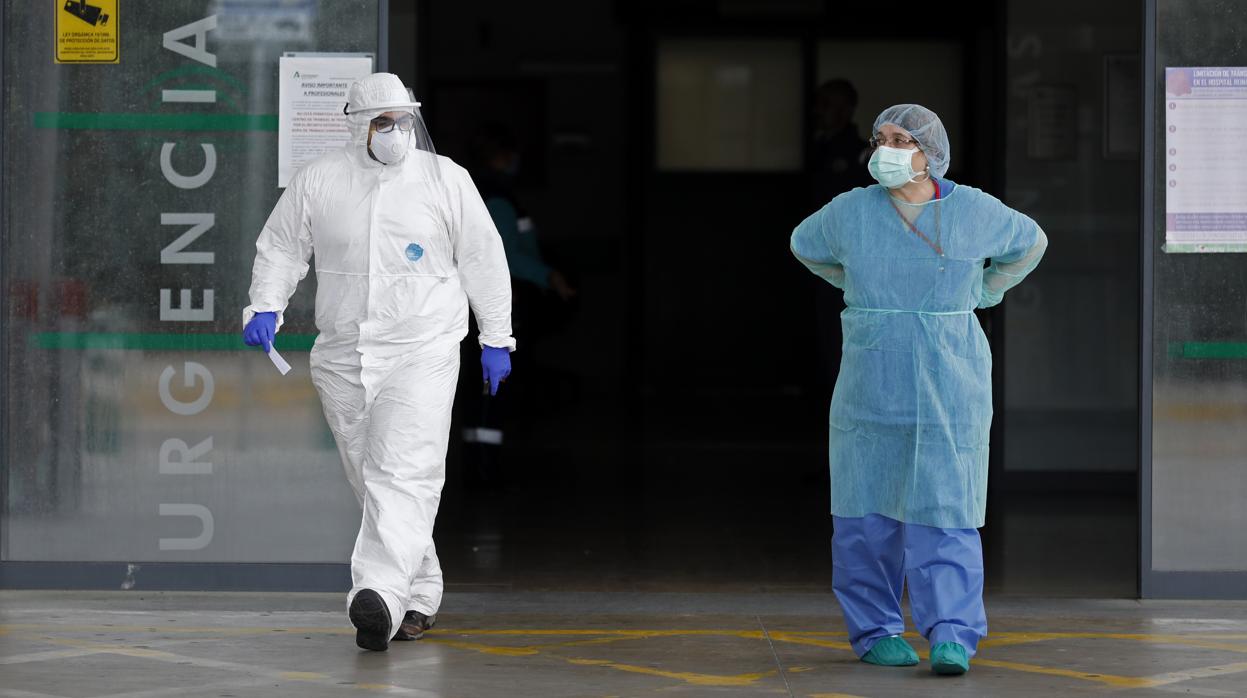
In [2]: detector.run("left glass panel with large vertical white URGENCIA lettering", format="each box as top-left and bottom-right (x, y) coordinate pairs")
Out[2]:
(0, 0), (379, 562)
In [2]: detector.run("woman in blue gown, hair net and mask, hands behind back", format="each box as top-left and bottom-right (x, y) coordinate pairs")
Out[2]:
(792, 105), (1047, 674)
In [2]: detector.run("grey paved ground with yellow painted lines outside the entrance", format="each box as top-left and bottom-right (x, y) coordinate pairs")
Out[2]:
(0, 591), (1247, 698)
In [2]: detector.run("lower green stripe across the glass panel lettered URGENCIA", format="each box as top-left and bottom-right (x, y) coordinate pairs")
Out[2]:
(31, 332), (315, 351)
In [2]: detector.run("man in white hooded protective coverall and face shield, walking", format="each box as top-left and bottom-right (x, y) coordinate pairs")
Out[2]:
(243, 74), (515, 651)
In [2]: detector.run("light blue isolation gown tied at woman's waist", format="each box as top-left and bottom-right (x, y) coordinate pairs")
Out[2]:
(792, 181), (1047, 528)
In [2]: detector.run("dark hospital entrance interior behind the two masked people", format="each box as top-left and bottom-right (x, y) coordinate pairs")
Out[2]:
(389, 0), (1141, 597)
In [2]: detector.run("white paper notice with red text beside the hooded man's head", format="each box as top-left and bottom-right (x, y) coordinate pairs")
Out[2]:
(277, 55), (373, 187)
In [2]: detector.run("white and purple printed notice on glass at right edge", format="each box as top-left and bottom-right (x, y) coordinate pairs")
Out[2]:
(1165, 67), (1247, 252)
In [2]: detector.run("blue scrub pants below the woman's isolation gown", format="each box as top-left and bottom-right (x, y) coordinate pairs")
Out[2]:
(832, 514), (988, 657)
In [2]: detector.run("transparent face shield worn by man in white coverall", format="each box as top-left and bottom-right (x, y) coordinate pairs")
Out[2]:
(343, 90), (441, 182)
